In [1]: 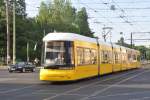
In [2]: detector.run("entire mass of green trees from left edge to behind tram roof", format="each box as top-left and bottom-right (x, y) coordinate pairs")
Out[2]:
(0, 0), (93, 62)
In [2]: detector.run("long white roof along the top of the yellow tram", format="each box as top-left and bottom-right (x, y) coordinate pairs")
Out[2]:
(43, 32), (136, 51)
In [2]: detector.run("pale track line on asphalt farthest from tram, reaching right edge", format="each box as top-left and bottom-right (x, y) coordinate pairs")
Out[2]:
(79, 70), (150, 100)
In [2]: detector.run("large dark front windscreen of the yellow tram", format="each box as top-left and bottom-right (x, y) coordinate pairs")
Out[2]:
(45, 41), (74, 69)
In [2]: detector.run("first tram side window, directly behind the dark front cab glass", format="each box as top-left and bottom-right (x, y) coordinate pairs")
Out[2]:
(77, 48), (84, 65)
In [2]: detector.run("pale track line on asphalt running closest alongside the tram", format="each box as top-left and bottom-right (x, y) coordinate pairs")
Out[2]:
(43, 70), (139, 100)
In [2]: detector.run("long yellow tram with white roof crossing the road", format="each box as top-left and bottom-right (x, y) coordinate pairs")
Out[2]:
(40, 33), (140, 81)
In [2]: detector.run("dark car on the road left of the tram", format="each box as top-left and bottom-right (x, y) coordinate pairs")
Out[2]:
(8, 62), (35, 73)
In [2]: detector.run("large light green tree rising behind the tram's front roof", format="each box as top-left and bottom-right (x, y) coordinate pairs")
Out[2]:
(37, 0), (76, 32)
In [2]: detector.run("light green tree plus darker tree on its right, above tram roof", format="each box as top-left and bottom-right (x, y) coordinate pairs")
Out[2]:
(37, 0), (93, 37)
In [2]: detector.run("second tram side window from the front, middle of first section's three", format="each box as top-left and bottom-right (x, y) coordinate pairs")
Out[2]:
(84, 49), (91, 64)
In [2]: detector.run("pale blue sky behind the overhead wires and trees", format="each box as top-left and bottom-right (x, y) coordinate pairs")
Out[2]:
(26, 0), (150, 47)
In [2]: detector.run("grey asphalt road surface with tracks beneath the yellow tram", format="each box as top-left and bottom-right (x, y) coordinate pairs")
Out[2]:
(0, 65), (150, 100)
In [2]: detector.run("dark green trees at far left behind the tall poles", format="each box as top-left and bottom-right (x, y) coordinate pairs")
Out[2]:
(0, 0), (43, 62)
